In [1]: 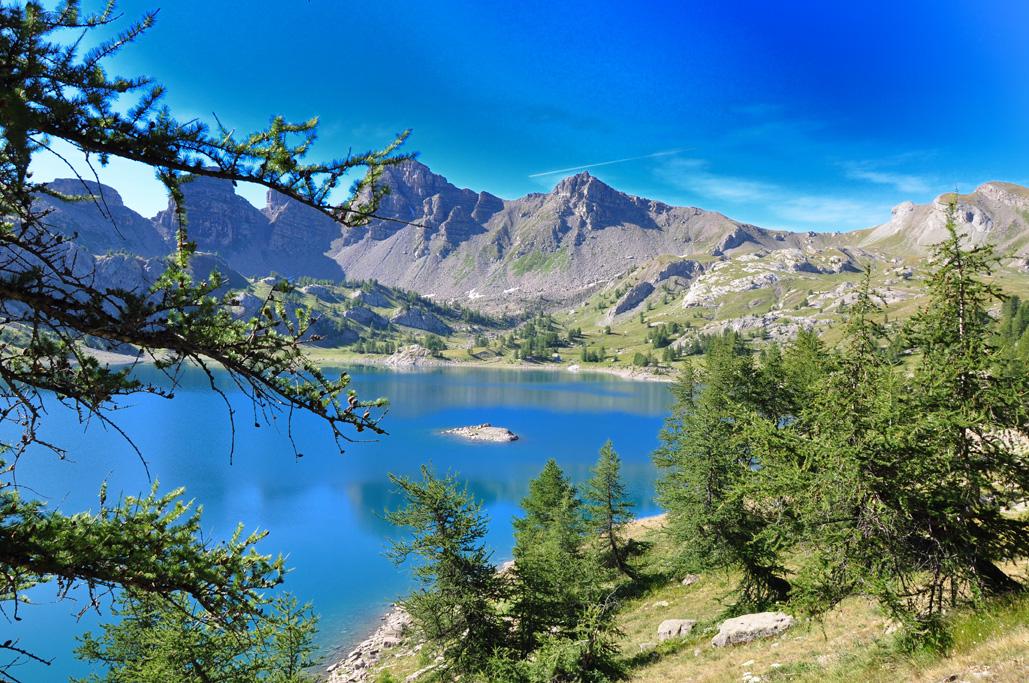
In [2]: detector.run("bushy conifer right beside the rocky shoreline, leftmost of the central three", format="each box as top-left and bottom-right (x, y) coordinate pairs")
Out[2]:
(387, 466), (506, 675)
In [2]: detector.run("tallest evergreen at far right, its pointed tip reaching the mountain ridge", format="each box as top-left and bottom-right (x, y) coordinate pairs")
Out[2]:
(903, 206), (1029, 612)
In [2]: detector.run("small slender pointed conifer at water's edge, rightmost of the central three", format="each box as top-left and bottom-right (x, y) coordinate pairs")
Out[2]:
(583, 440), (634, 578)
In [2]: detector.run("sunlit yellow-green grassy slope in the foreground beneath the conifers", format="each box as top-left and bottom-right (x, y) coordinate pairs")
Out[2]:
(371, 517), (1029, 683)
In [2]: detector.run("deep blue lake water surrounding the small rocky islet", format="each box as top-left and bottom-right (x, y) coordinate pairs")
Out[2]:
(6, 368), (671, 681)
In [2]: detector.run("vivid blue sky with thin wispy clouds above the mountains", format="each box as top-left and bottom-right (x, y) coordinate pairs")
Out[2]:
(30, 0), (1029, 229)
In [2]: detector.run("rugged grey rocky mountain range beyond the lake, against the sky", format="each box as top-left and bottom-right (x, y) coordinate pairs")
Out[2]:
(34, 161), (1029, 312)
